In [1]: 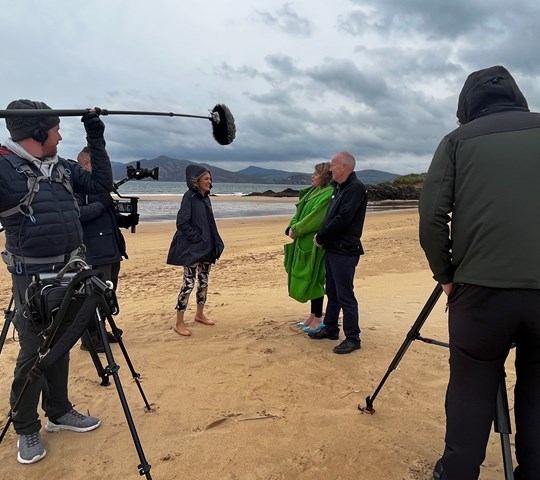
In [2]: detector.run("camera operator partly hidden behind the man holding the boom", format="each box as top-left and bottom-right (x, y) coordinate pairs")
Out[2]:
(75, 147), (138, 353)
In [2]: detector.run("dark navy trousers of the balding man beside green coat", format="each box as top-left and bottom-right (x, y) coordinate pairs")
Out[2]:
(324, 252), (360, 342)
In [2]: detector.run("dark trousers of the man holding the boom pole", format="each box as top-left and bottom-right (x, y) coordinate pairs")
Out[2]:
(10, 275), (72, 435)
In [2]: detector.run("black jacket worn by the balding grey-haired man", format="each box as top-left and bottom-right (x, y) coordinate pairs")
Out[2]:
(317, 172), (367, 255)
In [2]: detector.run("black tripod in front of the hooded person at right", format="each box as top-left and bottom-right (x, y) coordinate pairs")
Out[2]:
(358, 284), (514, 480)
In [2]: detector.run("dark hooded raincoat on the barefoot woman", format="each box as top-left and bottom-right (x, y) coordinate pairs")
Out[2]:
(167, 165), (224, 266)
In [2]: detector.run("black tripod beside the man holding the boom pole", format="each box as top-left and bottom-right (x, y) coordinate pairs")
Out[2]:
(0, 259), (152, 480)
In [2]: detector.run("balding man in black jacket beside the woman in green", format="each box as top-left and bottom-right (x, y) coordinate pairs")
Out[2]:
(309, 152), (367, 354)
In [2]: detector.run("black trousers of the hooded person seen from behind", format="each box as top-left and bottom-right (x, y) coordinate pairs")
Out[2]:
(442, 284), (540, 480)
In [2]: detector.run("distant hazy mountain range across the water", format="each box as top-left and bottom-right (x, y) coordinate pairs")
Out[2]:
(111, 155), (399, 185)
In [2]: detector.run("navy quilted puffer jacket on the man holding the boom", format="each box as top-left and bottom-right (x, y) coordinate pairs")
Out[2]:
(0, 138), (113, 273)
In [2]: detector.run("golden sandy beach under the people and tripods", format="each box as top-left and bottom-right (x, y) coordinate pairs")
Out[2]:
(0, 203), (514, 480)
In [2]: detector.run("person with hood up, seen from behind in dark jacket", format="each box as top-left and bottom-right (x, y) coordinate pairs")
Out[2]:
(420, 66), (540, 480)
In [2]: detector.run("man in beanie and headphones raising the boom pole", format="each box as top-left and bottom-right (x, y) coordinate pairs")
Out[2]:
(0, 100), (113, 464)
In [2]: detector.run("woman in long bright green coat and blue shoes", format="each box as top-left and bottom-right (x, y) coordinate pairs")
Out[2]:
(284, 163), (333, 333)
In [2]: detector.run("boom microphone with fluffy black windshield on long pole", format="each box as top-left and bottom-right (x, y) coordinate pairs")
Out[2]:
(0, 104), (236, 145)
